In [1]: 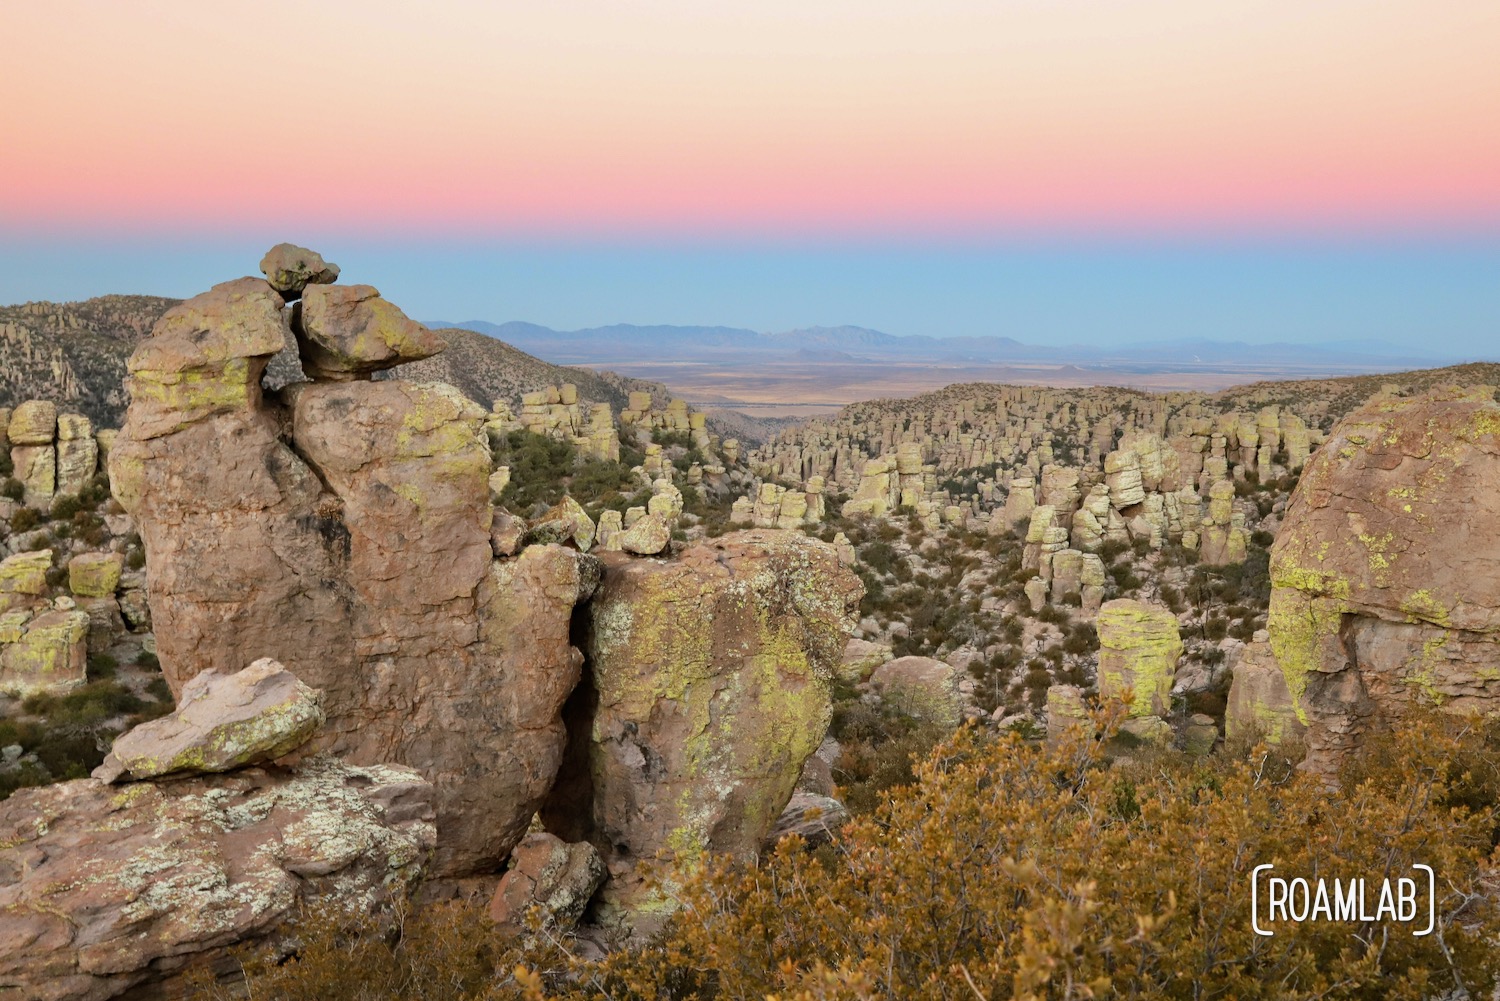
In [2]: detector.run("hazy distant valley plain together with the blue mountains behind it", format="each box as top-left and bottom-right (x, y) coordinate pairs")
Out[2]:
(431, 321), (1487, 416)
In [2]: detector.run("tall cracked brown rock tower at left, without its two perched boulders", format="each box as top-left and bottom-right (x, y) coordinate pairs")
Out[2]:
(110, 279), (597, 875)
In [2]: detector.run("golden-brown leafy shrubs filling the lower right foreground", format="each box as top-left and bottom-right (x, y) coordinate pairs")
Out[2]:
(217, 708), (1500, 1001)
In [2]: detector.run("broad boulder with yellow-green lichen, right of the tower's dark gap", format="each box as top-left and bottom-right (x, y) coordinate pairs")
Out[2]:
(549, 530), (864, 932)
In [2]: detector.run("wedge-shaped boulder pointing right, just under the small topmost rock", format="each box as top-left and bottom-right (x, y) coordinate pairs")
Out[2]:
(291, 285), (447, 381)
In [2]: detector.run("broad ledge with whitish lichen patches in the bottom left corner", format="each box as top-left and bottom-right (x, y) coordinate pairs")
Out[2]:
(0, 758), (437, 1001)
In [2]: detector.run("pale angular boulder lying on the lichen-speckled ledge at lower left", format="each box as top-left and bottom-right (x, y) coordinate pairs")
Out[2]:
(95, 657), (324, 782)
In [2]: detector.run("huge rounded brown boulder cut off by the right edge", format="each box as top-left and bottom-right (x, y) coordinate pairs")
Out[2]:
(1269, 387), (1500, 770)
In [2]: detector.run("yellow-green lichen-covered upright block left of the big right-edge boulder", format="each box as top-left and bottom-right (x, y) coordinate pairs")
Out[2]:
(1095, 597), (1182, 716)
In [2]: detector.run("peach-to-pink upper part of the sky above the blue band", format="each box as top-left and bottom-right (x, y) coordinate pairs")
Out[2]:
(0, 0), (1500, 236)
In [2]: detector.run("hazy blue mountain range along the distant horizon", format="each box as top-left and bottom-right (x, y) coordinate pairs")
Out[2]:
(429, 320), (1470, 371)
